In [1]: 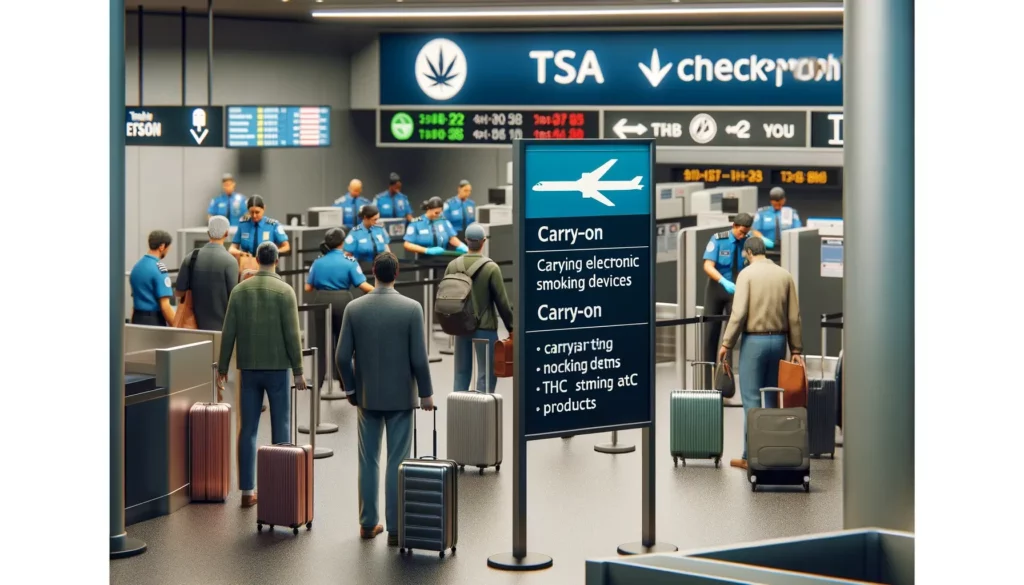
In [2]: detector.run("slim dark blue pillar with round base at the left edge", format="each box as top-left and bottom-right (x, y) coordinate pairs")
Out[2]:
(108, 0), (145, 558)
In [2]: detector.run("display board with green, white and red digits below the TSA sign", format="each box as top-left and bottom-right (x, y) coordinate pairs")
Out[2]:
(378, 109), (601, 145)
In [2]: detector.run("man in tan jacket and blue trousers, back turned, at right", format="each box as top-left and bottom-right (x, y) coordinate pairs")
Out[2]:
(718, 237), (804, 469)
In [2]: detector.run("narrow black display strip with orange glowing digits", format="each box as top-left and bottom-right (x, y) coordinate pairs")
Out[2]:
(675, 165), (843, 187)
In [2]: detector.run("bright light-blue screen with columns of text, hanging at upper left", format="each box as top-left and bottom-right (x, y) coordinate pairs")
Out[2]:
(226, 106), (331, 149)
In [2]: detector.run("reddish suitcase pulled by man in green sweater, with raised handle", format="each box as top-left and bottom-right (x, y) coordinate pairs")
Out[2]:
(256, 347), (317, 534)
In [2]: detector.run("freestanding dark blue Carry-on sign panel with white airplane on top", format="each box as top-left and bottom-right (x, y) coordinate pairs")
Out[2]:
(515, 140), (654, 440)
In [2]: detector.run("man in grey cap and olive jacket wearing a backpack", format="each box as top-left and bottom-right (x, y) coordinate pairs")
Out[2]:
(444, 223), (512, 392)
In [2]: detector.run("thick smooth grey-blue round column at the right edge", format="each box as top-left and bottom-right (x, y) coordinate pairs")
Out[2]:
(843, 0), (914, 532)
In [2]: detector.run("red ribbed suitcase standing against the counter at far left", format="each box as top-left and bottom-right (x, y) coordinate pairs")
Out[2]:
(188, 363), (231, 502)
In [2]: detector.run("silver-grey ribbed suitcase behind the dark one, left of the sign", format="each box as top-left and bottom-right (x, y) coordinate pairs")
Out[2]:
(446, 339), (504, 475)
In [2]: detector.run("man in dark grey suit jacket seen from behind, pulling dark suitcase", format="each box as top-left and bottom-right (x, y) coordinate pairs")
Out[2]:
(335, 252), (434, 546)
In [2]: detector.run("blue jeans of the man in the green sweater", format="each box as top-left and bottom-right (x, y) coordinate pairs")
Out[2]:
(239, 370), (292, 490)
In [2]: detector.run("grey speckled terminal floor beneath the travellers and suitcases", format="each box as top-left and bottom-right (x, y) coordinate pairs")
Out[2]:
(111, 357), (843, 585)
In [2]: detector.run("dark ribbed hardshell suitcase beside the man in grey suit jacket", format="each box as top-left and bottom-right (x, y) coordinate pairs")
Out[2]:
(398, 410), (459, 558)
